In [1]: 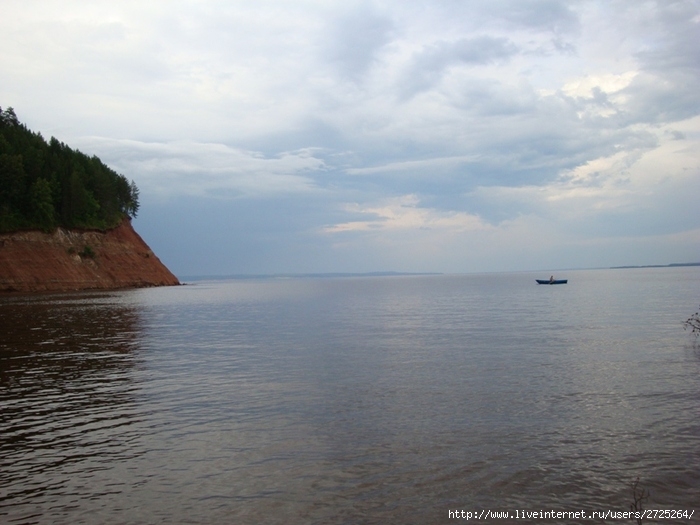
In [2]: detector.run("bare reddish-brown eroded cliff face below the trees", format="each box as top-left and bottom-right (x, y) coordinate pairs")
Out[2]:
(0, 220), (180, 292)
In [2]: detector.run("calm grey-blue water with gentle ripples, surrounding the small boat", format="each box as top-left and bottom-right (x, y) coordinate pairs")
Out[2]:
(0, 268), (700, 524)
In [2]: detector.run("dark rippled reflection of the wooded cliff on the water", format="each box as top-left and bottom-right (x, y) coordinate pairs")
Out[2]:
(0, 294), (142, 522)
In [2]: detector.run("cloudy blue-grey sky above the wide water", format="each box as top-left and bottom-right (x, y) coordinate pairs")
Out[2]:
(0, 0), (700, 276)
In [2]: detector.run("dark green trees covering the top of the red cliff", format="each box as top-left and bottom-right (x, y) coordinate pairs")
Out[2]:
(0, 108), (139, 232)
